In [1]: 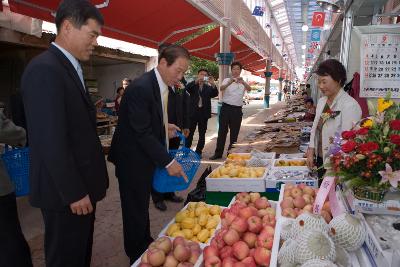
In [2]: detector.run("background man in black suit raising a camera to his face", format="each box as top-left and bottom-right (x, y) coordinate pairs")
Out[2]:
(186, 69), (218, 157)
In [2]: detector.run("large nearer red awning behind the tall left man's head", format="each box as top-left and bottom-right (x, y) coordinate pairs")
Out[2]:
(8, 0), (212, 48)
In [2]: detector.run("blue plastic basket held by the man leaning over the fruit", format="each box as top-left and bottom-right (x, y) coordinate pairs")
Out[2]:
(153, 133), (200, 193)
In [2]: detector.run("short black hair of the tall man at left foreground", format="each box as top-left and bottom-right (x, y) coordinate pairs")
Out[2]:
(55, 0), (104, 31)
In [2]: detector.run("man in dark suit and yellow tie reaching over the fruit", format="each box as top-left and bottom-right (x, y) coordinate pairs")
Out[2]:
(109, 45), (189, 263)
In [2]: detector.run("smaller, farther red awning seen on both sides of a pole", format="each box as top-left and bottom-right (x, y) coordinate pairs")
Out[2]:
(183, 28), (265, 70)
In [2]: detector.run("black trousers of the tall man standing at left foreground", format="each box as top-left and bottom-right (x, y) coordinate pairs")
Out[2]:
(42, 203), (96, 267)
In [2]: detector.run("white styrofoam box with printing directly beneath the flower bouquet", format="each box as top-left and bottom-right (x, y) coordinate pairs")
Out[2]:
(343, 185), (400, 215)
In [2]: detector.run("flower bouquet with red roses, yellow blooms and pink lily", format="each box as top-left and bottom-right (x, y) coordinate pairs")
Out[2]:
(329, 96), (400, 202)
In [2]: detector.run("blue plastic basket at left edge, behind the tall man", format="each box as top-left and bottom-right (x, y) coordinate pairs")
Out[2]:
(1, 145), (29, 197)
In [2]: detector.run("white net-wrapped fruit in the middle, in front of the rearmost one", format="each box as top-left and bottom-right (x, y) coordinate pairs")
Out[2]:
(295, 230), (336, 263)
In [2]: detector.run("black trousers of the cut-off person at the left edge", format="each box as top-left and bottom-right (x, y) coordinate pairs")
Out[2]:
(0, 193), (33, 267)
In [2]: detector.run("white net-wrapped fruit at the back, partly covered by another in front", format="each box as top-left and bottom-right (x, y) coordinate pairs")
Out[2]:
(290, 212), (329, 239)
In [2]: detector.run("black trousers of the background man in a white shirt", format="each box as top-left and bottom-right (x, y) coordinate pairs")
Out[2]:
(215, 103), (243, 156)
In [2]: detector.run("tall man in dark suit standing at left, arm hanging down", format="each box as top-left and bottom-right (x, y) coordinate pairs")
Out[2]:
(21, 0), (108, 267)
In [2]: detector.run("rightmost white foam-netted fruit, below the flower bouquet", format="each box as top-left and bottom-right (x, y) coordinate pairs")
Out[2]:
(329, 213), (366, 251)
